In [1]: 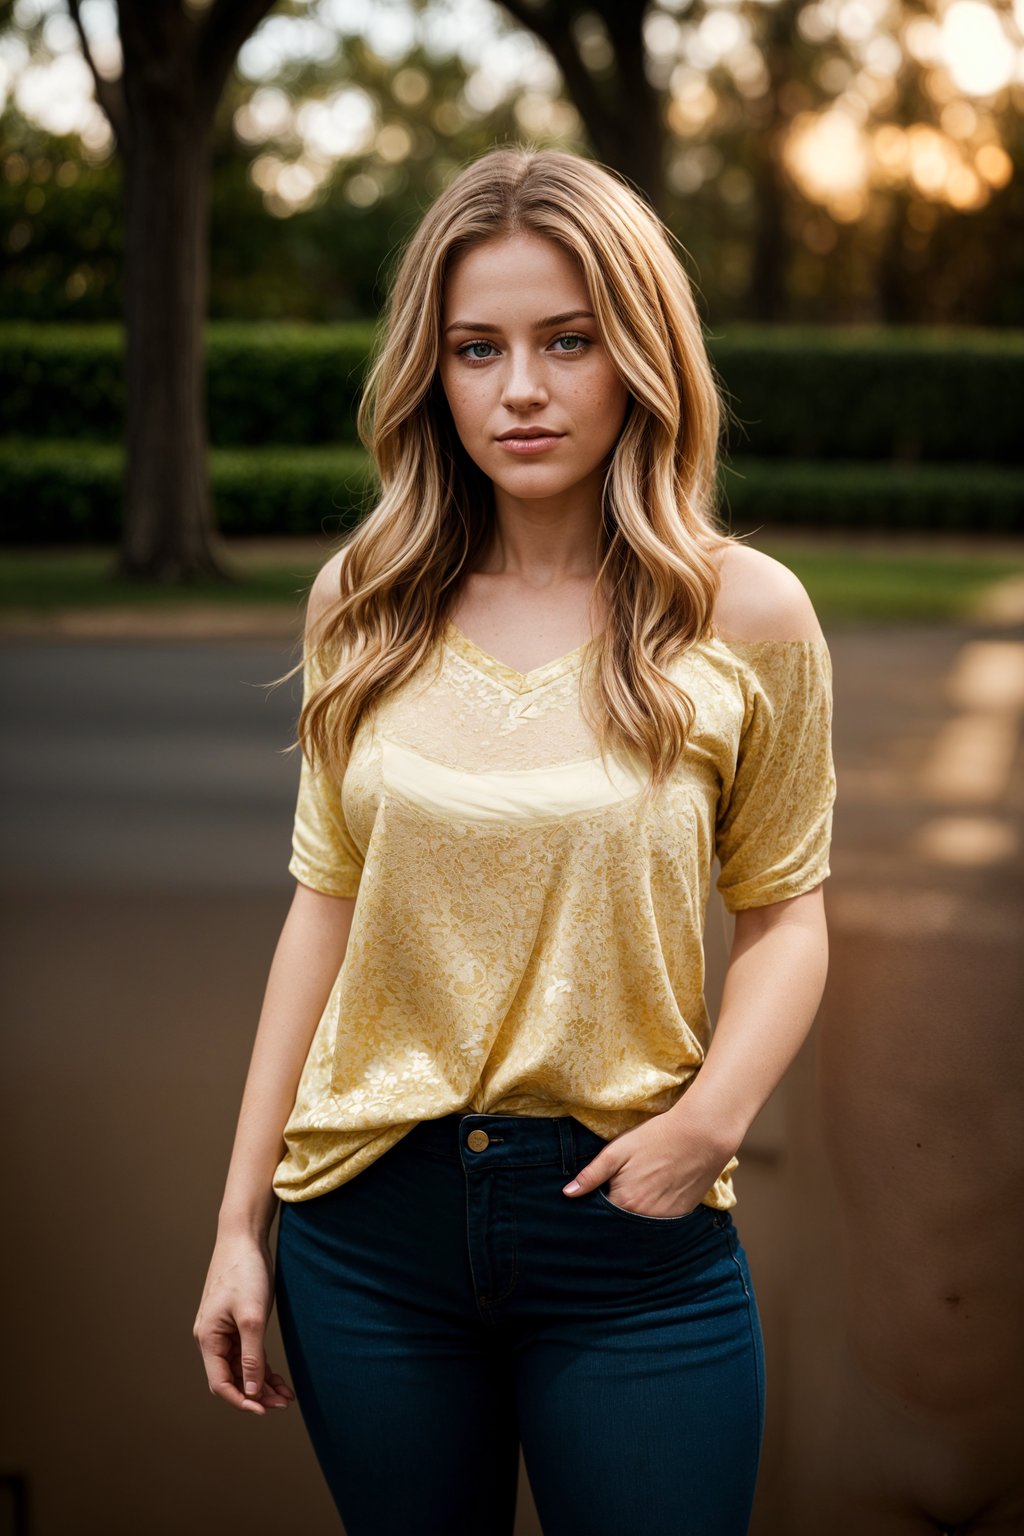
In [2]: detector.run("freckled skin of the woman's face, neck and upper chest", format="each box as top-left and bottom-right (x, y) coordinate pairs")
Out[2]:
(439, 233), (629, 671)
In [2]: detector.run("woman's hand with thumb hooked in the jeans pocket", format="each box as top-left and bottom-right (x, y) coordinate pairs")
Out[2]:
(563, 1115), (729, 1217)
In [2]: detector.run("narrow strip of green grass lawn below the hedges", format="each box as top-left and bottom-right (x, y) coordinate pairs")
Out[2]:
(0, 530), (1024, 624)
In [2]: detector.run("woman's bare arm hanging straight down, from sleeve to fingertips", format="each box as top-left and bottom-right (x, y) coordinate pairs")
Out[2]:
(192, 883), (355, 1415)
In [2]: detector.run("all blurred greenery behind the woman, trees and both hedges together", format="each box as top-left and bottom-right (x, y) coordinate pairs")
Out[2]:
(0, 0), (1024, 577)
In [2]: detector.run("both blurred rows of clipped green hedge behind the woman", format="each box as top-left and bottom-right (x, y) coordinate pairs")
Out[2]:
(0, 321), (1024, 545)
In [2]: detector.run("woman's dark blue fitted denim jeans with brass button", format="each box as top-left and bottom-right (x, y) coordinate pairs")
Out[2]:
(276, 1114), (765, 1536)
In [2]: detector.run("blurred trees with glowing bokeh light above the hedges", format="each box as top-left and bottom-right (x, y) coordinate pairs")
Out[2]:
(0, 0), (1024, 326)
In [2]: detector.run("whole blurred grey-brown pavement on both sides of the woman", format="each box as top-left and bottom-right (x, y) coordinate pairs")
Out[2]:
(0, 627), (1024, 1536)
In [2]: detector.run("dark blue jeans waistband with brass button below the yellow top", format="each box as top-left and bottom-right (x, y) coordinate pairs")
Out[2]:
(399, 1111), (606, 1174)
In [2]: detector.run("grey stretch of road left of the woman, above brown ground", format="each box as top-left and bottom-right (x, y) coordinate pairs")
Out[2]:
(0, 641), (301, 894)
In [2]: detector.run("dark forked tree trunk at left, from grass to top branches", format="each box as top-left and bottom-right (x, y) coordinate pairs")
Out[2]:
(68, 0), (273, 582)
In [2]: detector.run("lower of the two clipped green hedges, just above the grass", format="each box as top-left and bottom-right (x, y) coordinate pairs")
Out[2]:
(0, 438), (1024, 544)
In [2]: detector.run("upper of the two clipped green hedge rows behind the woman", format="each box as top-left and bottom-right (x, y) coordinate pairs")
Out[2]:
(0, 323), (1024, 464)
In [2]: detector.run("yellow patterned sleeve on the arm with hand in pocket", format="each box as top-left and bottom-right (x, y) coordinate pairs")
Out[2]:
(715, 637), (835, 912)
